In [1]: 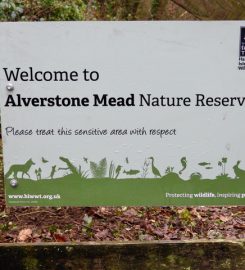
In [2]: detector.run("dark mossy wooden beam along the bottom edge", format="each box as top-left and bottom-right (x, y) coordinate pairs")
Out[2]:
(0, 241), (245, 270)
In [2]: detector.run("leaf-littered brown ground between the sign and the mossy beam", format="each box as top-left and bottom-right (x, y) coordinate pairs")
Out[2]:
(0, 141), (245, 243)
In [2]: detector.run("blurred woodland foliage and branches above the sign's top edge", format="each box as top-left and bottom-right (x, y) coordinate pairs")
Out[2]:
(0, 0), (245, 21)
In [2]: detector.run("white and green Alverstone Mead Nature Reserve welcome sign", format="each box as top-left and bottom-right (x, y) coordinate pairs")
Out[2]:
(0, 21), (245, 206)
